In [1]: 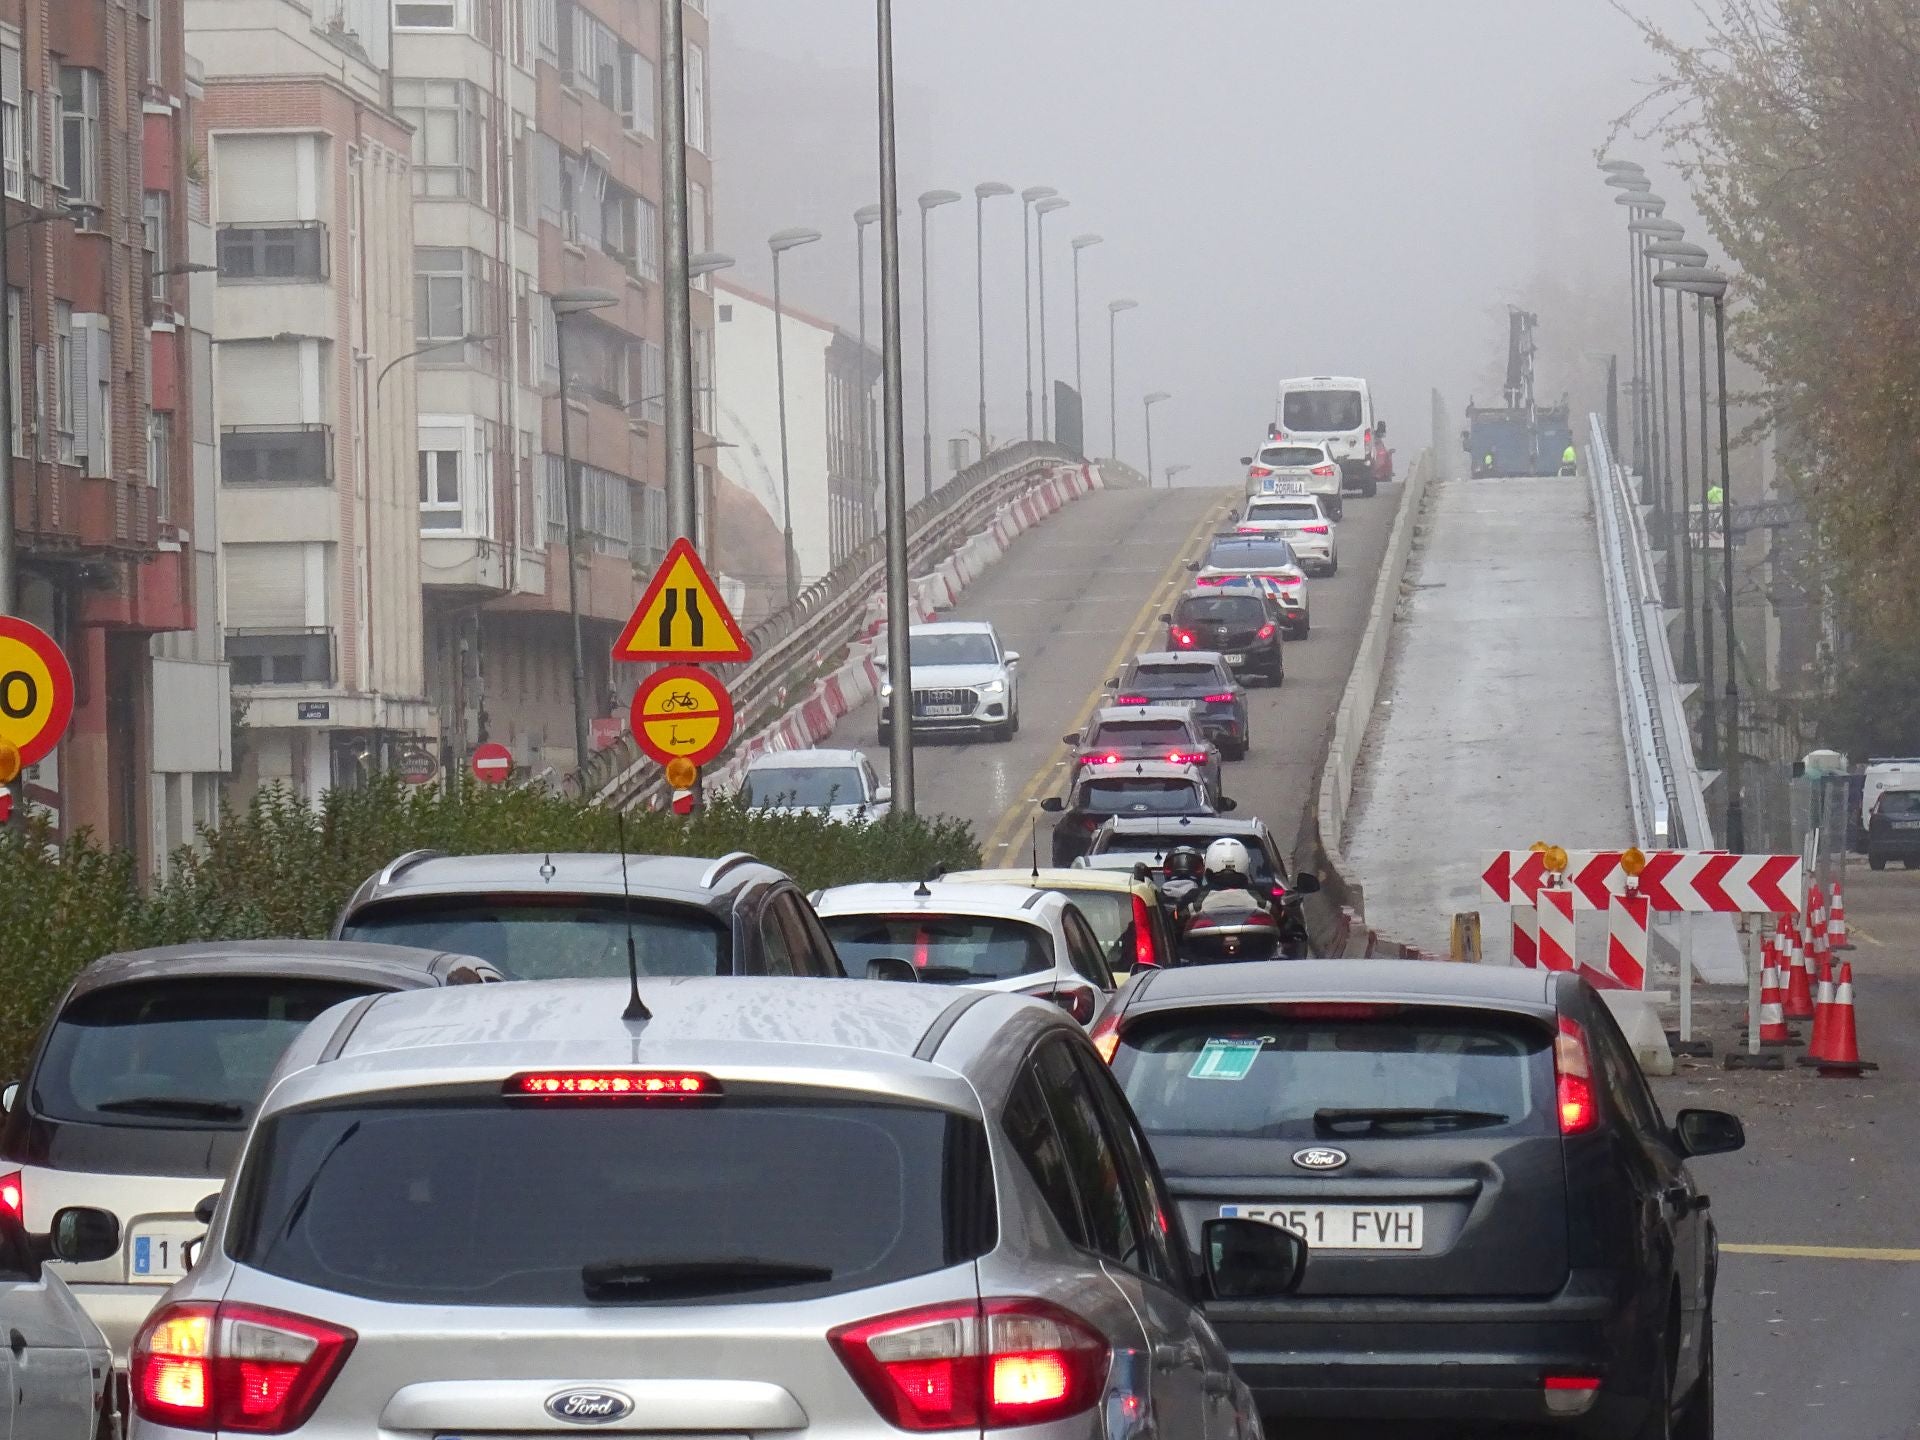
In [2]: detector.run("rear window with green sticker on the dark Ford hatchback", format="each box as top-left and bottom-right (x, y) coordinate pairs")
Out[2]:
(1114, 1004), (1553, 1140)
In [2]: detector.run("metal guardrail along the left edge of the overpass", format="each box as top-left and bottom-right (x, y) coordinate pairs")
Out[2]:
(588, 440), (1083, 808)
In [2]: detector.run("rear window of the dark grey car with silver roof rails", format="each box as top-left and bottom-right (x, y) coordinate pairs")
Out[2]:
(342, 895), (732, 979)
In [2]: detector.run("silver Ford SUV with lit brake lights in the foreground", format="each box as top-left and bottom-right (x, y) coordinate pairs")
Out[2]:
(131, 977), (1306, 1440)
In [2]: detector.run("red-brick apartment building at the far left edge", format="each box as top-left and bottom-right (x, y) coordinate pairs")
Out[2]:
(0, 0), (227, 864)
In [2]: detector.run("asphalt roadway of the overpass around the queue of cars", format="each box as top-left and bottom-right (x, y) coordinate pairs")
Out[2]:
(833, 482), (1400, 866)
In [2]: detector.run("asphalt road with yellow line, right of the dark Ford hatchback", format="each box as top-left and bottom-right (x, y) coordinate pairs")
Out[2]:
(1655, 860), (1920, 1440)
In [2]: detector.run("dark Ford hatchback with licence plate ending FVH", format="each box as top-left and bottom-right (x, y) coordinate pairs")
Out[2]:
(1094, 960), (1745, 1440)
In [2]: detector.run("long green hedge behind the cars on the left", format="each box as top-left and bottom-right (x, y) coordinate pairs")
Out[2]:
(0, 780), (979, 1079)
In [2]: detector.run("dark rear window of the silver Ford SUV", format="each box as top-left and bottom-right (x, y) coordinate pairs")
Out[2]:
(227, 1094), (993, 1308)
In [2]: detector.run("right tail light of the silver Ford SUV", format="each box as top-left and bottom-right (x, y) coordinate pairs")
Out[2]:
(828, 1300), (1110, 1430)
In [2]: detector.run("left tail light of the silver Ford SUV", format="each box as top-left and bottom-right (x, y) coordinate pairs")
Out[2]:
(129, 1300), (359, 1434)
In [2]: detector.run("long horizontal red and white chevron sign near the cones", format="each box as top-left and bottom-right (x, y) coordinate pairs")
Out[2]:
(1480, 851), (1805, 916)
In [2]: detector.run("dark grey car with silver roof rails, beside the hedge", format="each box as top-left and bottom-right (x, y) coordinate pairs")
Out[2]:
(334, 851), (847, 979)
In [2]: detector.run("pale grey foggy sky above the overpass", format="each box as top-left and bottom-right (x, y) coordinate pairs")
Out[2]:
(710, 0), (1699, 484)
